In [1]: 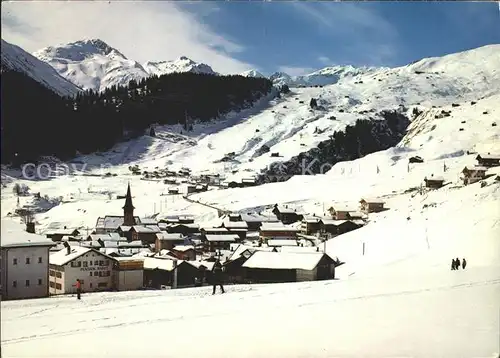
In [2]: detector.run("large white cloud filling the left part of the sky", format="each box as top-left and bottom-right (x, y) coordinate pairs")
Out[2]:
(2, 1), (250, 73)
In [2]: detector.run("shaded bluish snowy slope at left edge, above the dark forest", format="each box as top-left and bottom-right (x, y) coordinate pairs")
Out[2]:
(1, 39), (80, 96)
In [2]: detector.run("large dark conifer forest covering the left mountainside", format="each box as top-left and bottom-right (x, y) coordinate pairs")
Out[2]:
(1, 70), (272, 165)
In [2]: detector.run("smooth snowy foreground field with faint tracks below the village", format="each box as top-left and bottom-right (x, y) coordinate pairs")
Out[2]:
(2, 263), (500, 358)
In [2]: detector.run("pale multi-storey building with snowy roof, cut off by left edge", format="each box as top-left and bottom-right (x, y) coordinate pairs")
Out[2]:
(0, 220), (55, 300)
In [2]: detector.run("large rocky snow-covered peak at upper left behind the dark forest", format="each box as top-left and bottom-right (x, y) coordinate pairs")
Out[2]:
(33, 39), (148, 91)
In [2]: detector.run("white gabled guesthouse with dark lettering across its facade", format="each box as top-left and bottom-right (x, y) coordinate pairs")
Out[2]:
(49, 243), (116, 295)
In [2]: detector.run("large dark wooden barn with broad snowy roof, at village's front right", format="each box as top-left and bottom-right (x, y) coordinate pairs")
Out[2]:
(242, 251), (335, 283)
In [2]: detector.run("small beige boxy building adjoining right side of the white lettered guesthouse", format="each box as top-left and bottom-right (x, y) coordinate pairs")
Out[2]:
(113, 257), (145, 291)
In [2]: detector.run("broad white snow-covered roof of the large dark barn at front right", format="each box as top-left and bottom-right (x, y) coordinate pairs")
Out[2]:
(242, 251), (324, 270)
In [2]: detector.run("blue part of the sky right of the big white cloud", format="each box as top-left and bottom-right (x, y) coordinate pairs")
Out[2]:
(181, 2), (500, 73)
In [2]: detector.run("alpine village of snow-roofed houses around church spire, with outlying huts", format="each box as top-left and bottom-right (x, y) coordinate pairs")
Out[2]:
(1, 154), (500, 300)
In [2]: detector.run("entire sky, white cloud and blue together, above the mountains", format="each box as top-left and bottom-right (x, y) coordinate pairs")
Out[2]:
(2, 1), (500, 75)
